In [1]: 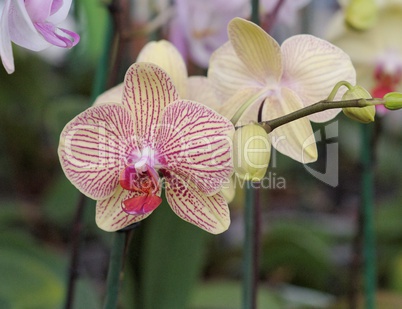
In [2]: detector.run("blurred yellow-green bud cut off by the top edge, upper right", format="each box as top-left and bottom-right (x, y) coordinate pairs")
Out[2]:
(345, 0), (377, 30)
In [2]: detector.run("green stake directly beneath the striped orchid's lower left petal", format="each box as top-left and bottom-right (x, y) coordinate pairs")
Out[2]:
(103, 231), (128, 309)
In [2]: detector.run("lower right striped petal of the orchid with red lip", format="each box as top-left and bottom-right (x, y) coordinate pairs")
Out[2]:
(166, 175), (230, 234)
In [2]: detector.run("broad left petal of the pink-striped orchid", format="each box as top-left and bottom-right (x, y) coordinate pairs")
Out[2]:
(58, 104), (139, 200)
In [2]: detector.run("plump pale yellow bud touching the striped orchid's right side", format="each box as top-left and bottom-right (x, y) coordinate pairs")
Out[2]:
(233, 123), (271, 181)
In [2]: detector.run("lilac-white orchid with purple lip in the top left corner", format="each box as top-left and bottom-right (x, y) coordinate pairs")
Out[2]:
(0, 0), (80, 74)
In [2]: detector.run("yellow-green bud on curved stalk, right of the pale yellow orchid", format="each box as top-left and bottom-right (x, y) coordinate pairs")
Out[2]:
(342, 86), (375, 123)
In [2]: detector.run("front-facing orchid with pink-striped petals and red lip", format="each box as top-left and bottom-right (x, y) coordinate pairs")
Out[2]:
(59, 63), (234, 234)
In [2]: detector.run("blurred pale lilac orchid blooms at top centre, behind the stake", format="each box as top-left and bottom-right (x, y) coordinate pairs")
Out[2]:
(169, 0), (310, 68)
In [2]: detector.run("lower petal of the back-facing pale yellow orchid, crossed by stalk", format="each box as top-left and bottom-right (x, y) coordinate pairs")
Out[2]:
(262, 88), (318, 163)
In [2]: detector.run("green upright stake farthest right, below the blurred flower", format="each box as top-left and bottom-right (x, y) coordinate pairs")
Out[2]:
(361, 125), (377, 309)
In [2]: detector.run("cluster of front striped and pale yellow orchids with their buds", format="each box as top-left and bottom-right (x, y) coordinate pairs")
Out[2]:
(59, 18), (400, 234)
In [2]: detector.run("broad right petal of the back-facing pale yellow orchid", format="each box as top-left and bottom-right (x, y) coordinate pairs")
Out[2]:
(282, 35), (356, 122)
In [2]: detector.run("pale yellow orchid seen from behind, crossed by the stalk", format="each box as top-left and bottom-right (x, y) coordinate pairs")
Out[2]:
(208, 18), (355, 163)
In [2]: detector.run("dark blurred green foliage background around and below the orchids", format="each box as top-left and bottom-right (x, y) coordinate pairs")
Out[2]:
(0, 0), (402, 309)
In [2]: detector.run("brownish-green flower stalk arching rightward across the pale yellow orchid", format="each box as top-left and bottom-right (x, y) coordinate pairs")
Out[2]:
(260, 98), (384, 133)
